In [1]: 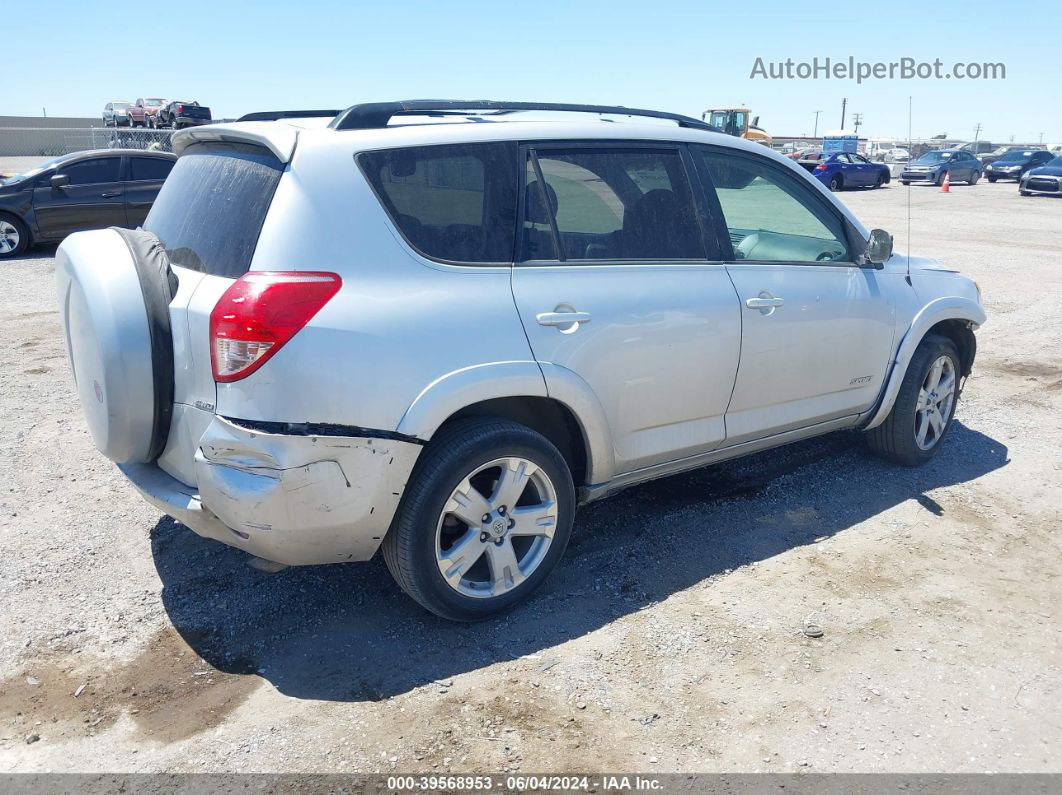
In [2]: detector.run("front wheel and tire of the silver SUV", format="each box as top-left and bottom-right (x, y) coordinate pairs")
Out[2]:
(867, 334), (962, 466)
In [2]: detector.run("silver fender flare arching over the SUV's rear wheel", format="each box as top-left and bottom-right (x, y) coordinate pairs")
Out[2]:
(395, 361), (615, 483)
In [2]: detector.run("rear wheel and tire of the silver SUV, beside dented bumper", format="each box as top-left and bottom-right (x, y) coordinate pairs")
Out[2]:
(383, 418), (576, 621)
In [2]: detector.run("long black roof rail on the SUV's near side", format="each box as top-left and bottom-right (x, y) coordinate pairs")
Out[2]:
(327, 100), (723, 133)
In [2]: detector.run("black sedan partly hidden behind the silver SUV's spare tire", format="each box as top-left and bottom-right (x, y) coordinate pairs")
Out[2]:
(0, 149), (177, 258)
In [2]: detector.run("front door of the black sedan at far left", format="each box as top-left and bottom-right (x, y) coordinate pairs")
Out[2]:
(33, 156), (126, 239)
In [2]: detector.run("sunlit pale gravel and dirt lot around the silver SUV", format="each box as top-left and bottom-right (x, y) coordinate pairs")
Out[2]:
(0, 170), (1062, 773)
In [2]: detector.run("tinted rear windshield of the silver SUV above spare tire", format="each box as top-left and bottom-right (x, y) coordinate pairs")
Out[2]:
(144, 143), (284, 279)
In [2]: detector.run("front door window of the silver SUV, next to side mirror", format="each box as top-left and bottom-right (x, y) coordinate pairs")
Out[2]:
(695, 146), (852, 262)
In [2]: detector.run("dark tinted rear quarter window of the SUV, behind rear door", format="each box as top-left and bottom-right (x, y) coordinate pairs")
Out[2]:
(358, 142), (517, 263)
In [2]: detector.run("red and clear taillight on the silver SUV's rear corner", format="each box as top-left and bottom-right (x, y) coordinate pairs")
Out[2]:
(210, 271), (343, 383)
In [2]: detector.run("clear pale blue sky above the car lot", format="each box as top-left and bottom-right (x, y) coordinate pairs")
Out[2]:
(12, 0), (1062, 143)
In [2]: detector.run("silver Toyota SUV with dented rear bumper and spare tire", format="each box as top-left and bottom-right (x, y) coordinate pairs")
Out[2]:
(56, 101), (984, 620)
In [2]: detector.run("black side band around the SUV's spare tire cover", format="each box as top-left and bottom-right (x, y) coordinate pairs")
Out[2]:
(110, 226), (177, 463)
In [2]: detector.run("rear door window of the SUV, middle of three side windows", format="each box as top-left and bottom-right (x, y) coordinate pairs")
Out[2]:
(525, 148), (705, 260)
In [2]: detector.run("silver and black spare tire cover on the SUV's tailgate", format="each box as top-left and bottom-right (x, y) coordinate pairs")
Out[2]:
(55, 229), (175, 464)
